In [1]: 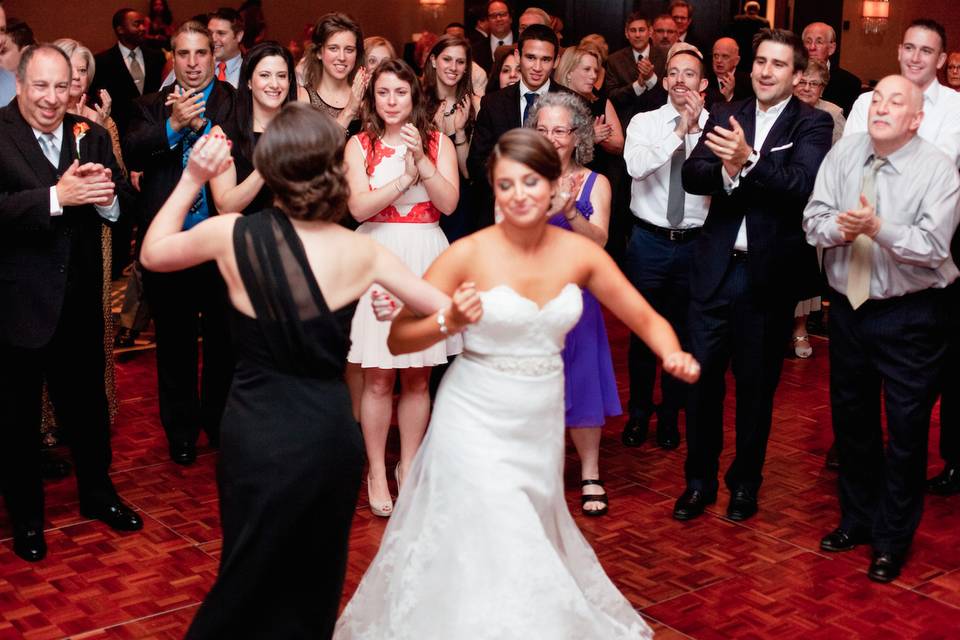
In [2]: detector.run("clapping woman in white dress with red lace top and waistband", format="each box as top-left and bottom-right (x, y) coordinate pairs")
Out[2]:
(346, 59), (461, 516)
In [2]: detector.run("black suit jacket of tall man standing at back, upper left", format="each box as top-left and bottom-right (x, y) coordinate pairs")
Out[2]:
(90, 44), (166, 139)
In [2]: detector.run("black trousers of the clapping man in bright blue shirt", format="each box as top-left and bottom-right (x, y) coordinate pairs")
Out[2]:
(143, 262), (233, 442)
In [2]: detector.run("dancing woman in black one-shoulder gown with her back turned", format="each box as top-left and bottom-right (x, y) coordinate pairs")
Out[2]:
(141, 104), (449, 639)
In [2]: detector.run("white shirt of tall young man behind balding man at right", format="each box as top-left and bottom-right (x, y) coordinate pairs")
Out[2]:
(843, 80), (960, 167)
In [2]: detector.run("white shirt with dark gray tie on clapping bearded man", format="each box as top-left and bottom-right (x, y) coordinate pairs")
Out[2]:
(623, 101), (710, 229)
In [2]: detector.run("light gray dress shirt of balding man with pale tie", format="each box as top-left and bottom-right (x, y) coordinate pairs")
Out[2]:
(803, 133), (960, 300)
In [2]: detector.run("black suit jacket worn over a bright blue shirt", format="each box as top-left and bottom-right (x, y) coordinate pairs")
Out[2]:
(123, 79), (235, 245)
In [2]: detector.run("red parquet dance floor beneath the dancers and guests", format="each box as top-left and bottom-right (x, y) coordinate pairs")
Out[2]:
(0, 323), (960, 640)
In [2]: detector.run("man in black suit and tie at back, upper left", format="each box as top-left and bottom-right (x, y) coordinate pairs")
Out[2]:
(90, 8), (165, 139)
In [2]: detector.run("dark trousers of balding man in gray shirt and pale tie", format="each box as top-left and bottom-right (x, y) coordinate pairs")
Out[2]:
(830, 289), (947, 553)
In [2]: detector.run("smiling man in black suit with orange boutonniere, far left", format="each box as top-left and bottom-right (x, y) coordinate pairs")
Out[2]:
(0, 45), (143, 561)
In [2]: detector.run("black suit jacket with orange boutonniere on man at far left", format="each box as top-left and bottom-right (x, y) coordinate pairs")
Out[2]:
(0, 100), (124, 349)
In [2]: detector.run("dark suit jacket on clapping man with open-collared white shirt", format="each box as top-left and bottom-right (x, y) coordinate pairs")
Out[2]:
(683, 98), (833, 303)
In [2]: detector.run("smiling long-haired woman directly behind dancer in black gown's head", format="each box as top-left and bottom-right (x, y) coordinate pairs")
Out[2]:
(297, 13), (367, 135)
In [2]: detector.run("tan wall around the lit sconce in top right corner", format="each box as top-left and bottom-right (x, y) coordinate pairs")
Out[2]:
(840, 0), (960, 82)
